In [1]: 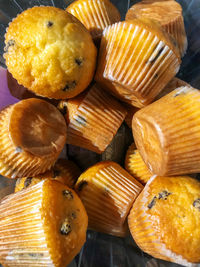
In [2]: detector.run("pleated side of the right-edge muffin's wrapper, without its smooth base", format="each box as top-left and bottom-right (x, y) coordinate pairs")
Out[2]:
(134, 87), (200, 176)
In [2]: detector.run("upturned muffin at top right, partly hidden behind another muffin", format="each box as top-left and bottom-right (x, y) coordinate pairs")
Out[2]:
(126, 0), (187, 56)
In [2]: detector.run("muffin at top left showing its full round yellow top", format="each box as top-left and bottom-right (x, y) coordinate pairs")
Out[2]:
(4, 6), (97, 99)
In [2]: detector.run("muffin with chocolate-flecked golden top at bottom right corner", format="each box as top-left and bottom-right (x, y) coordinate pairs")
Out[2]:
(128, 176), (200, 266)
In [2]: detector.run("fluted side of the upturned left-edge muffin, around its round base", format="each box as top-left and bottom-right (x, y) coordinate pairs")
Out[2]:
(0, 99), (66, 178)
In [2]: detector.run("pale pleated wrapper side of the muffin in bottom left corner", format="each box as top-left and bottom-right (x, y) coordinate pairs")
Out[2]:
(0, 183), (53, 267)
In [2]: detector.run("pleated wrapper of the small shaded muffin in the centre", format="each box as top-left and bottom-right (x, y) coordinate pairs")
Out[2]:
(67, 86), (126, 153)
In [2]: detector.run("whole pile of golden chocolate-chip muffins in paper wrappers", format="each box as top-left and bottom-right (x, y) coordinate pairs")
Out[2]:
(0, 0), (200, 267)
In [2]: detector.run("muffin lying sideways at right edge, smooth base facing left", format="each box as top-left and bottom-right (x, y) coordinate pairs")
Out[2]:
(132, 86), (200, 176)
